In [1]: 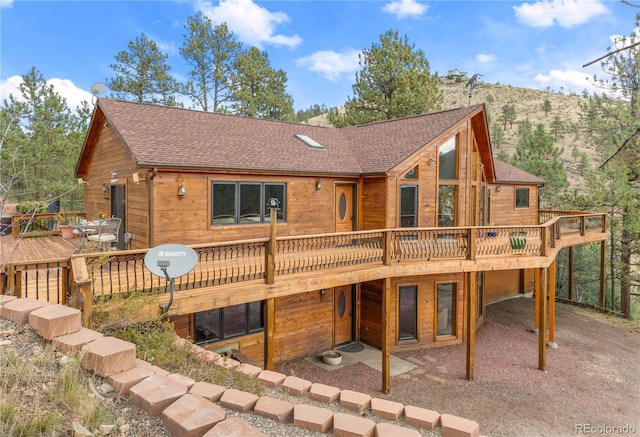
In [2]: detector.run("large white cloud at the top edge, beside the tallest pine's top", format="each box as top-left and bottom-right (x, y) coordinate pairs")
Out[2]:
(195, 0), (302, 48)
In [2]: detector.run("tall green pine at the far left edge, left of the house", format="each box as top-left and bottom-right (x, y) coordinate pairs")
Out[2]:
(0, 67), (90, 210)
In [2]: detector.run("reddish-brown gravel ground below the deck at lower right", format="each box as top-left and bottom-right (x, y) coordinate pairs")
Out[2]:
(276, 298), (640, 437)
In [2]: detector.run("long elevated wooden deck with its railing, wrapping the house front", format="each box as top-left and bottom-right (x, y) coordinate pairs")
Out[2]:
(0, 214), (606, 310)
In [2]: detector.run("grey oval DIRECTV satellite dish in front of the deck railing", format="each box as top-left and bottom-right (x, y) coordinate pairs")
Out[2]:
(144, 244), (198, 279)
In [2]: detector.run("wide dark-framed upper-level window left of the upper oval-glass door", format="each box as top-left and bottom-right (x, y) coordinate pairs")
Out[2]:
(211, 182), (286, 225)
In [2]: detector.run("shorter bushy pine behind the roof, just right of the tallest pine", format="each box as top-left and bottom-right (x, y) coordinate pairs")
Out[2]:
(230, 47), (294, 121)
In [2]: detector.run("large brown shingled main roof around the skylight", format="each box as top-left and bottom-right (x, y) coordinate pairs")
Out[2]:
(90, 99), (482, 175)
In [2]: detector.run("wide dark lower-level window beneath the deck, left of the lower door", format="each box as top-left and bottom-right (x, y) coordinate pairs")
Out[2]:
(194, 302), (264, 344)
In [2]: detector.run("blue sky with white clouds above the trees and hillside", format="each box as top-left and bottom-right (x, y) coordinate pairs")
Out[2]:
(0, 0), (640, 110)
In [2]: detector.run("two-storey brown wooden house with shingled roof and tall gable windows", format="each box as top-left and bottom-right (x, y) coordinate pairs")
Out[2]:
(76, 99), (605, 384)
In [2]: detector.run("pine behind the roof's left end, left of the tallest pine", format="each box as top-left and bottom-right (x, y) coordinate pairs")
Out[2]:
(107, 33), (179, 106)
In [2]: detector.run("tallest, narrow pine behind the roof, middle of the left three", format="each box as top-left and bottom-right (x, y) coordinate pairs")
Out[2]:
(180, 13), (242, 112)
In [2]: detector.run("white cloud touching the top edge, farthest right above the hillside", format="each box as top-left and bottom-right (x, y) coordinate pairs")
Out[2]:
(513, 0), (609, 28)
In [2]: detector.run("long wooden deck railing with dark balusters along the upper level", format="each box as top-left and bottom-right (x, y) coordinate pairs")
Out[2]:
(5, 211), (606, 303)
